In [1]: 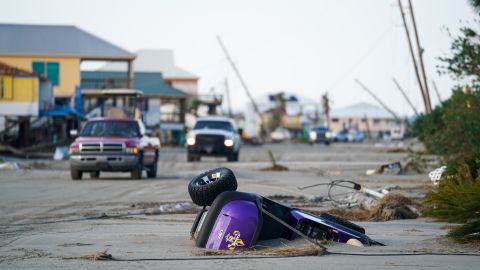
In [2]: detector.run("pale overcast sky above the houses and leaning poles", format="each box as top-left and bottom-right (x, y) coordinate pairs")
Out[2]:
(0, 0), (474, 115)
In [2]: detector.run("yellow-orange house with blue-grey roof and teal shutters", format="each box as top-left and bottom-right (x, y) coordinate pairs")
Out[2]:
(0, 24), (135, 103)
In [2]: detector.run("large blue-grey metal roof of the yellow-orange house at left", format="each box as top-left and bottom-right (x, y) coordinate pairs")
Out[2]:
(0, 24), (135, 60)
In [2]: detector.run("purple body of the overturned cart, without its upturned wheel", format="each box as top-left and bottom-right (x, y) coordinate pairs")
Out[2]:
(192, 191), (379, 250)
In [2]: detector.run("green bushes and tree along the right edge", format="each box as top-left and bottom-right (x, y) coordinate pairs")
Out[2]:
(413, 0), (480, 239)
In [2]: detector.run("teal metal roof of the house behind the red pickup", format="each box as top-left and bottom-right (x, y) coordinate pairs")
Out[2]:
(81, 71), (188, 98)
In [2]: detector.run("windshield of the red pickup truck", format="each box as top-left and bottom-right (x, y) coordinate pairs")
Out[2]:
(80, 121), (139, 137)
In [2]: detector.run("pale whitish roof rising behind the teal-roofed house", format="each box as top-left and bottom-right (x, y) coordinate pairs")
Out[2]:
(98, 50), (198, 80)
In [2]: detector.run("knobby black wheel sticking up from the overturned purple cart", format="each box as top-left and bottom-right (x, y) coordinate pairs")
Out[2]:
(188, 168), (237, 206)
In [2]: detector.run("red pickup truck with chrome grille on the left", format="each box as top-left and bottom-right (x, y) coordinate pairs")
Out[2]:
(69, 118), (160, 180)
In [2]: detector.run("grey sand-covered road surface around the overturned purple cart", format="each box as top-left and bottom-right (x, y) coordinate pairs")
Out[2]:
(0, 144), (480, 269)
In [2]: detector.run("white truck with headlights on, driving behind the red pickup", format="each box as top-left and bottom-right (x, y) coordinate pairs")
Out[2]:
(187, 116), (240, 162)
